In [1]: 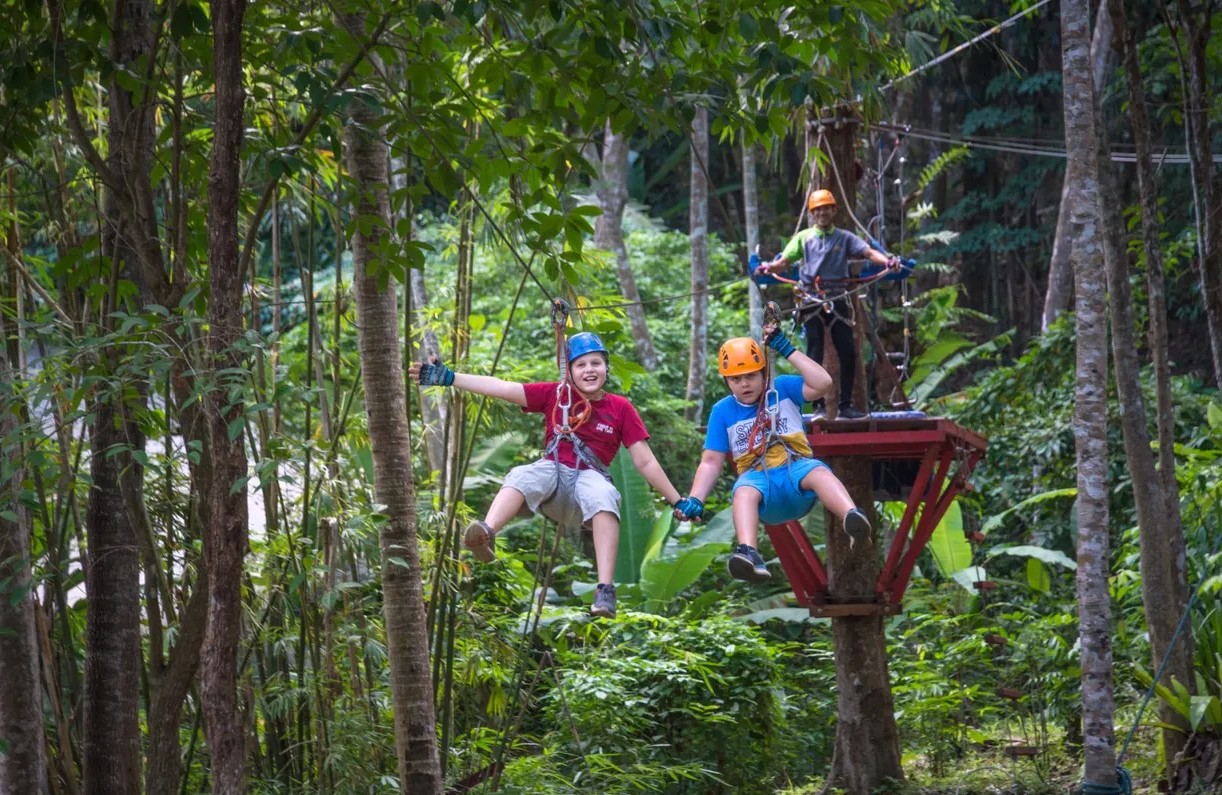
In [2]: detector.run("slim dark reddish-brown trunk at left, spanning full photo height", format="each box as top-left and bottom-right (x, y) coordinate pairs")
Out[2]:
(200, 0), (249, 795)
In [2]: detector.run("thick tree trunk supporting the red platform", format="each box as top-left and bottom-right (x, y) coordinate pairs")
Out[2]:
(803, 110), (904, 795)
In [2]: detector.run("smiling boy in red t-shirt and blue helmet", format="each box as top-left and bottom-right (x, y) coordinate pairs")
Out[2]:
(409, 331), (687, 618)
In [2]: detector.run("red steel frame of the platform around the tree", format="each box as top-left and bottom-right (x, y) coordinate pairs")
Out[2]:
(765, 418), (987, 615)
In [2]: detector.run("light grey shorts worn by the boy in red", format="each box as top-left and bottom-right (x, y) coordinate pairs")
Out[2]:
(505, 459), (620, 528)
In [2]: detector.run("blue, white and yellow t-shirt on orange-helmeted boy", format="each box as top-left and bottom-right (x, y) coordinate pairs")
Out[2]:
(704, 375), (814, 474)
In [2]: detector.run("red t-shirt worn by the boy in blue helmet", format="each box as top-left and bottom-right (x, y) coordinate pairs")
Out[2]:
(522, 381), (649, 469)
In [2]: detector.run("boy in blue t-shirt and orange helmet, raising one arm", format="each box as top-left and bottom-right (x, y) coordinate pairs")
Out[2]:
(675, 324), (871, 583)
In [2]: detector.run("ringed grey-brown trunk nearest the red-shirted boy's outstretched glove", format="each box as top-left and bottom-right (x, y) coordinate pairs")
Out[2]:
(345, 20), (442, 795)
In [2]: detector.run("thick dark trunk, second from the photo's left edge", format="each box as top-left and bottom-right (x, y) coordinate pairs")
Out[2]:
(78, 0), (160, 795)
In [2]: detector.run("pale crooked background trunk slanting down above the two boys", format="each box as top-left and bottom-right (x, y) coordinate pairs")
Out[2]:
(594, 121), (657, 372)
